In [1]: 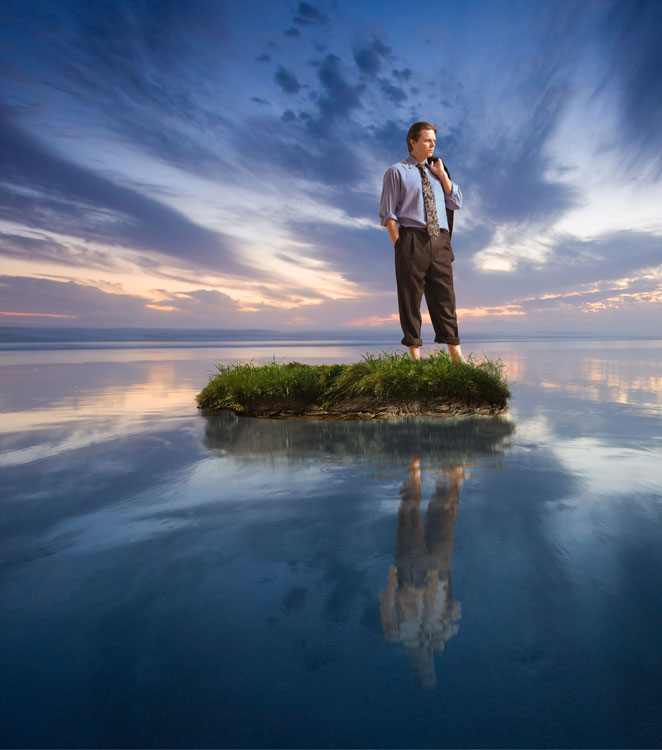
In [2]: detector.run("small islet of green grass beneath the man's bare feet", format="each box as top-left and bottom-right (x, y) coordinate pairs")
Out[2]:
(197, 351), (510, 413)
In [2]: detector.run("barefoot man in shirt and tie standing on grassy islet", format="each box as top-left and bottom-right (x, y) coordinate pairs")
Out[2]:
(379, 122), (465, 362)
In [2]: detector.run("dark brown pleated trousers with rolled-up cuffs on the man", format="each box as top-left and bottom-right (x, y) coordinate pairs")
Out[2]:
(395, 226), (460, 346)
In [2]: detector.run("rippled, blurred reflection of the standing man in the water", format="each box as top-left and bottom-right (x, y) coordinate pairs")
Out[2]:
(379, 458), (465, 689)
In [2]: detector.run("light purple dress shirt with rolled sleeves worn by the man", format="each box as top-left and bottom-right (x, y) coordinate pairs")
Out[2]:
(379, 154), (462, 229)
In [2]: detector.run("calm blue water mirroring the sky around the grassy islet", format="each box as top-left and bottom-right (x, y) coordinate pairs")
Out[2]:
(0, 341), (662, 747)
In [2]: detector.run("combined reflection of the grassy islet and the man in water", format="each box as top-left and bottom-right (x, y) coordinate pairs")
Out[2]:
(205, 412), (515, 689)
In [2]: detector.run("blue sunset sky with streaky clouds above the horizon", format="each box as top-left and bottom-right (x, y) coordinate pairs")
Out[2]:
(0, 0), (662, 334)
